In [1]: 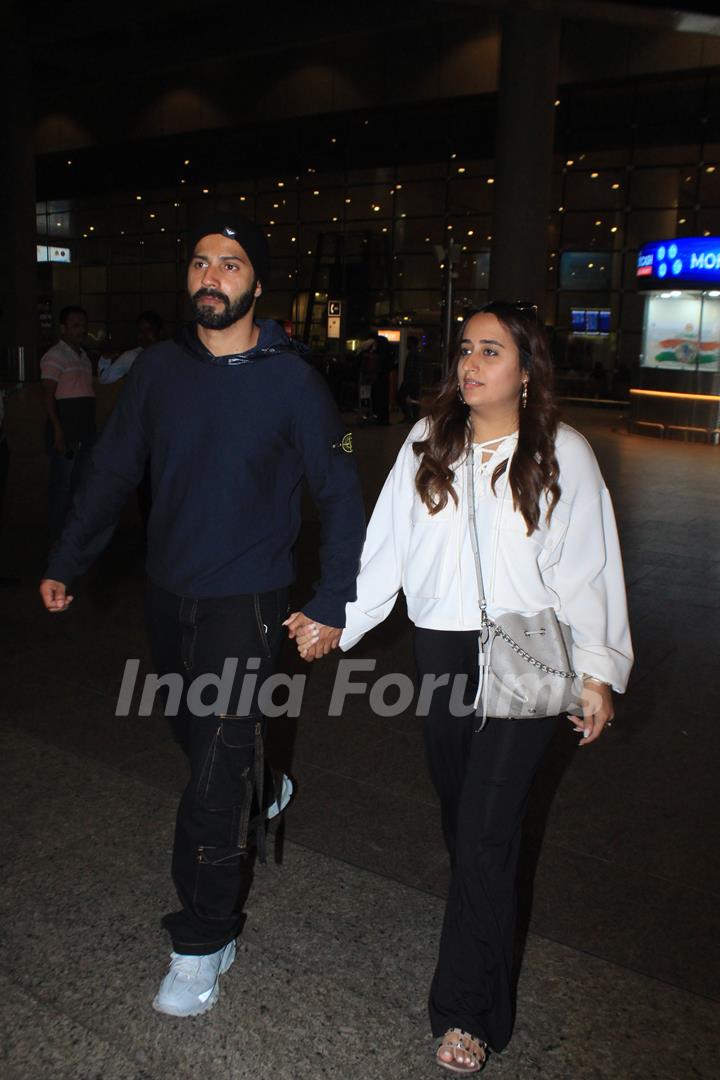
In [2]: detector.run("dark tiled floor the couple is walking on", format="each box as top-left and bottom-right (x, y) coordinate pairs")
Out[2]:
(0, 400), (720, 1080)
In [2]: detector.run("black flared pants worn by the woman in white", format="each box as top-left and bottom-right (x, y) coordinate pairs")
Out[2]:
(415, 629), (560, 1050)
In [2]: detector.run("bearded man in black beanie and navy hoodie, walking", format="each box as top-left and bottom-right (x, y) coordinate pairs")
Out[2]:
(41, 218), (365, 1016)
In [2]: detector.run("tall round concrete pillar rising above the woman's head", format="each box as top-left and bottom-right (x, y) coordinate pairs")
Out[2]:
(490, 5), (560, 312)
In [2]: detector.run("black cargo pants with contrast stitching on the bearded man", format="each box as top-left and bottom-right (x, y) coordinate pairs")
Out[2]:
(148, 583), (287, 956)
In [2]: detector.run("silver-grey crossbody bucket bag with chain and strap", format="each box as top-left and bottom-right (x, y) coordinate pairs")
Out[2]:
(465, 447), (582, 727)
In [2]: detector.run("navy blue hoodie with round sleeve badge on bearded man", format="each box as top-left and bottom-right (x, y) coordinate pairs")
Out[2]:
(45, 320), (365, 626)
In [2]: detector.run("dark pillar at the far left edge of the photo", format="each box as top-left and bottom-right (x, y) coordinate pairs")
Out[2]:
(0, 11), (38, 379)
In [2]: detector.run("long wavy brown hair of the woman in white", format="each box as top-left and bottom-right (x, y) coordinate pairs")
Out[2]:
(412, 300), (560, 536)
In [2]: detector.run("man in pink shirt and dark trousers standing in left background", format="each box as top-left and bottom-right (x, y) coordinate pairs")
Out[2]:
(40, 306), (96, 544)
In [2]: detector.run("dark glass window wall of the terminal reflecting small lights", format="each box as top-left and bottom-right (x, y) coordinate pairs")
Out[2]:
(37, 68), (720, 375)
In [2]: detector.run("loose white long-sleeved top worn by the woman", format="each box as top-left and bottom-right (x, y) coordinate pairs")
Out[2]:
(340, 420), (633, 693)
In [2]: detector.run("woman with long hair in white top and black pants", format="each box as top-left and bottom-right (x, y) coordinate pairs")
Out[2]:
(289, 302), (633, 1072)
